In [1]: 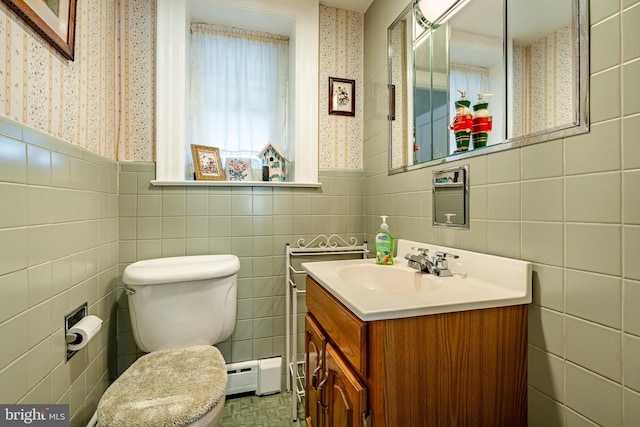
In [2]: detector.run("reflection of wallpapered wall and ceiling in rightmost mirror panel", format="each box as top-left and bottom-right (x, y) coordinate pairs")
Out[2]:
(507, 0), (579, 138)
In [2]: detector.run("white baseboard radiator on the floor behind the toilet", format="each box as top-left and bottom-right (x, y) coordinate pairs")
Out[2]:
(226, 357), (282, 396)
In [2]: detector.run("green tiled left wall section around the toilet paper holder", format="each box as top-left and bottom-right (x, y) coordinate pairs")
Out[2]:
(0, 118), (120, 426)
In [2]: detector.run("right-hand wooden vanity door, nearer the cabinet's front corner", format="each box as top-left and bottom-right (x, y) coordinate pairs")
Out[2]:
(323, 344), (367, 427)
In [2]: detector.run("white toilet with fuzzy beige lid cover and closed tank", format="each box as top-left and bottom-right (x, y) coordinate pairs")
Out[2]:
(96, 255), (240, 427)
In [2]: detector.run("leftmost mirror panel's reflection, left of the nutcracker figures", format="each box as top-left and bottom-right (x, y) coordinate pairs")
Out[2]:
(388, 0), (460, 170)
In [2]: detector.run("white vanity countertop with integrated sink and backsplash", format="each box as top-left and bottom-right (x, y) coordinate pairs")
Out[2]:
(302, 240), (532, 321)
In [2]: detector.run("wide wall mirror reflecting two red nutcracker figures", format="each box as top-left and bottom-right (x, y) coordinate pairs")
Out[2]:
(388, 0), (589, 173)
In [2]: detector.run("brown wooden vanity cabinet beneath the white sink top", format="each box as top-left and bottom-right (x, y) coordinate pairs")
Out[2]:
(305, 277), (527, 427)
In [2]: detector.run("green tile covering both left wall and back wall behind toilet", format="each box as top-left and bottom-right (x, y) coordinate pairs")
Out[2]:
(0, 119), (364, 426)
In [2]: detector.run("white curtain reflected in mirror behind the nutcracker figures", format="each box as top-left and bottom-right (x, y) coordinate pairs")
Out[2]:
(449, 64), (489, 153)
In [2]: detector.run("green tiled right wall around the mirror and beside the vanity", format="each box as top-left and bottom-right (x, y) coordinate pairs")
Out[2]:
(364, 0), (640, 427)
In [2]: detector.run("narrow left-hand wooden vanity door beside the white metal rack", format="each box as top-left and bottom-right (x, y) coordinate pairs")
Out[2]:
(304, 314), (326, 427)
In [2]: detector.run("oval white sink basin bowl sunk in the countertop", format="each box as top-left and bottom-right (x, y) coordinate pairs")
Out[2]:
(337, 263), (438, 294)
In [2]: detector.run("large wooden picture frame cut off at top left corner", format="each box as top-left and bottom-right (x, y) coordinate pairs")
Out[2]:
(2, 0), (76, 61)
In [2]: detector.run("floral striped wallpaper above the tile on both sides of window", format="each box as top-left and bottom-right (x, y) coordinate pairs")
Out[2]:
(0, 0), (364, 169)
